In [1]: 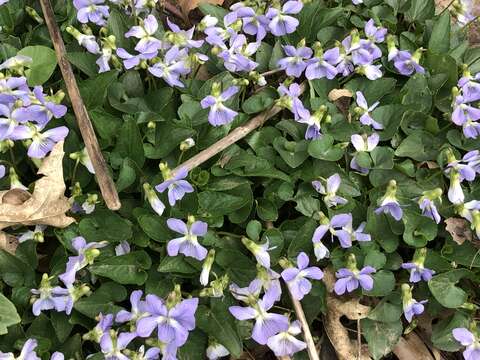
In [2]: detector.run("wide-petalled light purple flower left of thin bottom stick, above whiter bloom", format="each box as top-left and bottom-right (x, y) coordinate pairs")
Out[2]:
(229, 295), (289, 345)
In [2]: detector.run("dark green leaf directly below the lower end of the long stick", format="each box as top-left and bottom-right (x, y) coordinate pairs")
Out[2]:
(79, 209), (132, 243)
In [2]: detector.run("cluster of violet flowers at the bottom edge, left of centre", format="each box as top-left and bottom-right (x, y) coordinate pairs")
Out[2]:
(83, 286), (198, 360)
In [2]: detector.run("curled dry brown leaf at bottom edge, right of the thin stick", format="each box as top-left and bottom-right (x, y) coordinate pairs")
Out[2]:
(323, 268), (371, 360)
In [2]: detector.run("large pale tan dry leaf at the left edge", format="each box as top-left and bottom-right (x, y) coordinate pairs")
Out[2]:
(0, 141), (75, 230)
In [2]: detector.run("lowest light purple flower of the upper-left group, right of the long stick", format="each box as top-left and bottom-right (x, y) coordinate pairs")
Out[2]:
(148, 46), (191, 88)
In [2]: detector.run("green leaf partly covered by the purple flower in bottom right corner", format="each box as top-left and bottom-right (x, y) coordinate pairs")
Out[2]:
(432, 311), (470, 351)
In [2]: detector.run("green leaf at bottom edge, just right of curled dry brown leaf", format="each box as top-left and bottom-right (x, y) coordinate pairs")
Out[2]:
(361, 319), (403, 360)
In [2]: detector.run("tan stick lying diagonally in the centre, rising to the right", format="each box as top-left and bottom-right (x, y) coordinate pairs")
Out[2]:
(173, 84), (305, 174)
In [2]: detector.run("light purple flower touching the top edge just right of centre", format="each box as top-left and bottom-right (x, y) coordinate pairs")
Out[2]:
(265, 1), (303, 36)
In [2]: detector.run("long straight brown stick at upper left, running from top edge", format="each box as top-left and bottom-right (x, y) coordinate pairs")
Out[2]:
(40, 0), (121, 210)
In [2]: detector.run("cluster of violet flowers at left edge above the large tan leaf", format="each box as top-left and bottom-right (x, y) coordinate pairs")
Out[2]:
(0, 55), (68, 163)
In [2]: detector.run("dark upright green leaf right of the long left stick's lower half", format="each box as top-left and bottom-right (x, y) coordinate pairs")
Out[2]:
(115, 120), (145, 167)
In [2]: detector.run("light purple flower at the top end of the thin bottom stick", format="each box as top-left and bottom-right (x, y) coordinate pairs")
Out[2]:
(282, 252), (323, 300)
